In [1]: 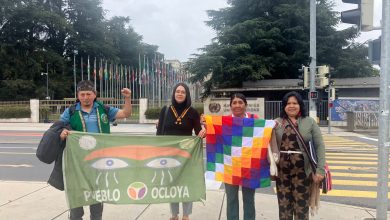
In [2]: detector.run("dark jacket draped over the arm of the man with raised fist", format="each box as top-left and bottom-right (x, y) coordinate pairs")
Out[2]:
(37, 121), (70, 190)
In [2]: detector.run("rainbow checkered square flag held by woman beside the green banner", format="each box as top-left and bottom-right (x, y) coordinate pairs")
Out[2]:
(205, 115), (275, 189)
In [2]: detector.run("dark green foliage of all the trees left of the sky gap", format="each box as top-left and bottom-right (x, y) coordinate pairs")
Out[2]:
(0, 0), (162, 100)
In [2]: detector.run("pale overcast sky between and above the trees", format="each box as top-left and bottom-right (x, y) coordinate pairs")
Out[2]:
(103, 0), (382, 61)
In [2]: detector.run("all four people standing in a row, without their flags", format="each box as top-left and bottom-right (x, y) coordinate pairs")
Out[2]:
(52, 81), (325, 220)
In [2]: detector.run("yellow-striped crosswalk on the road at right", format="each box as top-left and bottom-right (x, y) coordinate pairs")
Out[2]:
(323, 136), (390, 199)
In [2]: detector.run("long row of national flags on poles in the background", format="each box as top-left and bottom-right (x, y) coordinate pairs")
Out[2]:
(73, 54), (190, 100)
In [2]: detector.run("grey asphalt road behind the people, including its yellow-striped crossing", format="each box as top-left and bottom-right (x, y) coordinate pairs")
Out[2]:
(0, 130), (390, 208)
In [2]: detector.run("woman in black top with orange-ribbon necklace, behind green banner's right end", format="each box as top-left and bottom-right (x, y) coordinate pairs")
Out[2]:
(157, 83), (206, 220)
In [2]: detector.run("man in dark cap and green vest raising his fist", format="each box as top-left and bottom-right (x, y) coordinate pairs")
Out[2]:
(60, 80), (131, 220)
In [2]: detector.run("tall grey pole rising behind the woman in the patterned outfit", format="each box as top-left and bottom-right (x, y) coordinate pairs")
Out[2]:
(309, 0), (317, 121)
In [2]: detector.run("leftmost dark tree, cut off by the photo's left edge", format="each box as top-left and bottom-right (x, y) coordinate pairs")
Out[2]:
(0, 1), (68, 100)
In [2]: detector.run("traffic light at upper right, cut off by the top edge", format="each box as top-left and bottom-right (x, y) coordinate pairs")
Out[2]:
(341, 0), (374, 31)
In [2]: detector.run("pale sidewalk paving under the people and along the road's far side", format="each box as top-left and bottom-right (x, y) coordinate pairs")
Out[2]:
(0, 123), (384, 220)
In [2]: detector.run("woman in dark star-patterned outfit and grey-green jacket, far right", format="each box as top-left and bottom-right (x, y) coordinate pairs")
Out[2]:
(275, 92), (325, 220)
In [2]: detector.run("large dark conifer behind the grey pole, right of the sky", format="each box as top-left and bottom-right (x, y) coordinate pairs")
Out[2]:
(188, 0), (374, 95)
